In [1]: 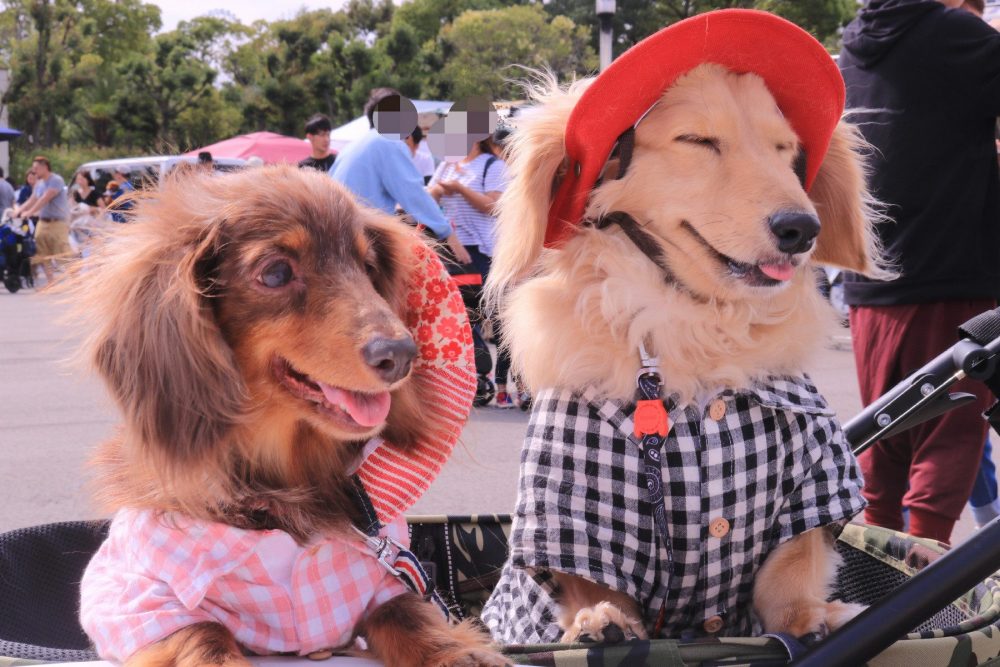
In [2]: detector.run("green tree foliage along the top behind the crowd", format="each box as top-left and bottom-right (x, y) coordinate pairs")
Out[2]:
(0, 0), (856, 160)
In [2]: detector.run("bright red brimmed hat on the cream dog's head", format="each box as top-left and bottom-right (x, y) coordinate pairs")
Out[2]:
(545, 9), (844, 247)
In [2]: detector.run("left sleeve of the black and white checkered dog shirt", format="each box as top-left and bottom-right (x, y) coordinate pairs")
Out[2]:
(510, 391), (656, 605)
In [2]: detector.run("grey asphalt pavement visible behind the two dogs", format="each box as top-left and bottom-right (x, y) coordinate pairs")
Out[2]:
(0, 290), (984, 542)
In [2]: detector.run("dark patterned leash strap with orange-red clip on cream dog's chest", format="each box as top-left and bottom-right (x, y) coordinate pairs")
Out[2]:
(632, 344), (674, 637)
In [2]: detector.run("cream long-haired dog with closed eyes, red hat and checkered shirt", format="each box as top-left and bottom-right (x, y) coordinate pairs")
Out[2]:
(482, 10), (891, 643)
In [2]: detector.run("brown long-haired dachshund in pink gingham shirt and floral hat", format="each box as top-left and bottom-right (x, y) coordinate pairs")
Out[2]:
(65, 167), (506, 667)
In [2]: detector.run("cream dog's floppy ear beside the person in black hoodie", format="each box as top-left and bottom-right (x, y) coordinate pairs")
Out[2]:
(809, 122), (887, 277)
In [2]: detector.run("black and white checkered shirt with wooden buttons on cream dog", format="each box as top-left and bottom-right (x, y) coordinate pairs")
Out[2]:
(482, 377), (865, 644)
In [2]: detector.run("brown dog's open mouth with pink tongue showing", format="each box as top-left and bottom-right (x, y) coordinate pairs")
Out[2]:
(271, 357), (392, 431)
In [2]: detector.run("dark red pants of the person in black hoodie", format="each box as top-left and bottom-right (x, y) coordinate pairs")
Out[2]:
(850, 299), (996, 542)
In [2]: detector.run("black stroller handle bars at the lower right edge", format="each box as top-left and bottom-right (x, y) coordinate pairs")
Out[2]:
(792, 308), (1000, 667)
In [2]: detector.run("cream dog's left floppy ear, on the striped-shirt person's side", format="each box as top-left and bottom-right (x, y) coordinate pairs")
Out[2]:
(486, 77), (585, 304)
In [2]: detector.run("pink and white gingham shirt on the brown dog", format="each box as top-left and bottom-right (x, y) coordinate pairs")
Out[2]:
(80, 510), (409, 662)
